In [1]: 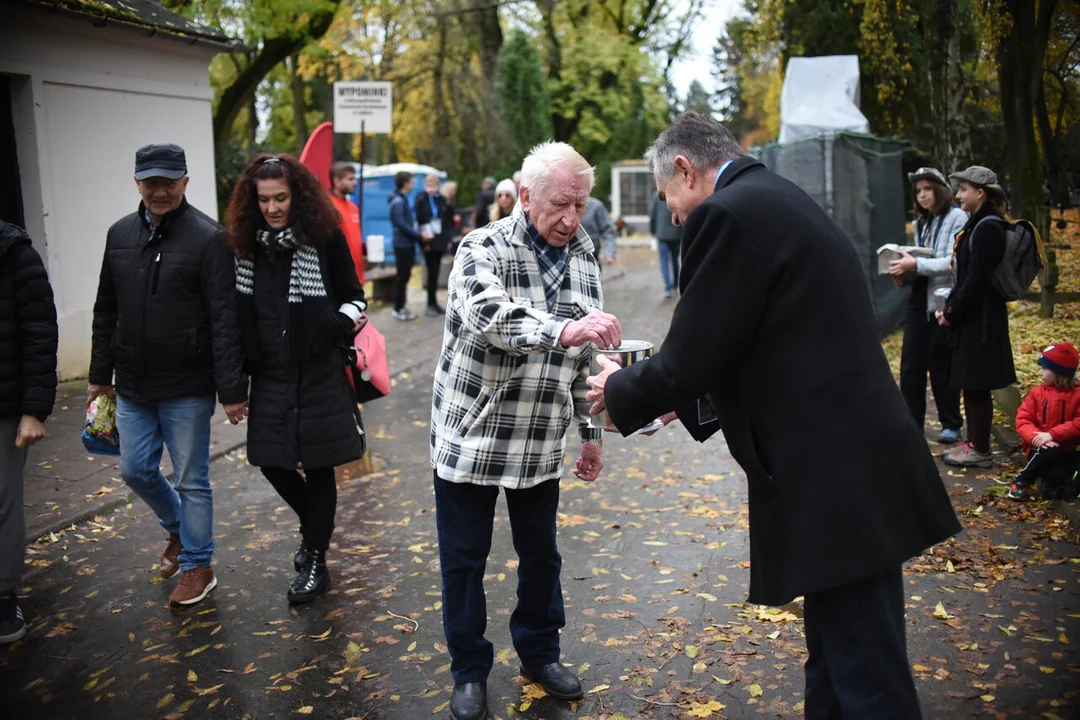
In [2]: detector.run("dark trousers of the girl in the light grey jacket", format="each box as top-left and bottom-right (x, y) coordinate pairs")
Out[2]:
(900, 295), (963, 430)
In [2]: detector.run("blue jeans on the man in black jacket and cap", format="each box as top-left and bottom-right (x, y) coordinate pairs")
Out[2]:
(117, 394), (214, 571)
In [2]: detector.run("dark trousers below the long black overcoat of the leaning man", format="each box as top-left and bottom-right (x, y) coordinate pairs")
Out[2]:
(805, 568), (922, 720)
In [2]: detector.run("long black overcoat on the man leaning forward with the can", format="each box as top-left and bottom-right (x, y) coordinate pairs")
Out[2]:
(605, 158), (960, 604)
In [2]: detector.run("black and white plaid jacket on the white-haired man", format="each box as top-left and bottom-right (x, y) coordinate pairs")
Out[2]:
(431, 205), (604, 489)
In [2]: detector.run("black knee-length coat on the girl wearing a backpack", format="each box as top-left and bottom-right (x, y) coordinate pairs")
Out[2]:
(945, 204), (1016, 390)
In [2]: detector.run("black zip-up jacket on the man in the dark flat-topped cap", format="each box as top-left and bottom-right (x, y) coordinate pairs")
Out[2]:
(90, 200), (247, 405)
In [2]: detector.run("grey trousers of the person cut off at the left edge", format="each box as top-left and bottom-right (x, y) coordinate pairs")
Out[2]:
(0, 418), (26, 596)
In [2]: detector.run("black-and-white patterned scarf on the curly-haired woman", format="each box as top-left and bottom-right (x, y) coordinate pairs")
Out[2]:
(235, 228), (341, 358)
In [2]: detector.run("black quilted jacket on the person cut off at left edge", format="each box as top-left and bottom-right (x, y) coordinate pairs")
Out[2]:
(0, 221), (57, 418)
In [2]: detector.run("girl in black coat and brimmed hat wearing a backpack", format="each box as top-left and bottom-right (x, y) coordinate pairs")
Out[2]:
(935, 165), (1016, 467)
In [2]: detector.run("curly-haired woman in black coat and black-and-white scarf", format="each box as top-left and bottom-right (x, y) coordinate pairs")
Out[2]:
(229, 154), (367, 602)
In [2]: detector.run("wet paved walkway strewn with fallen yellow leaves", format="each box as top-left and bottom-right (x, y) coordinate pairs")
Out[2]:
(10, 249), (1080, 720)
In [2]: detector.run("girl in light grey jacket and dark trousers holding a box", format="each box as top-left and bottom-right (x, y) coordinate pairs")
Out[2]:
(889, 167), (968, 444)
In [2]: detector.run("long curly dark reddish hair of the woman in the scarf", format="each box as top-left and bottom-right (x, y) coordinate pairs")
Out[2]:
(227, 153), (341, 257)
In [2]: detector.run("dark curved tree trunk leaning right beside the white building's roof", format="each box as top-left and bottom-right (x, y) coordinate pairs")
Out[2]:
(214, 0), (341, 151)
